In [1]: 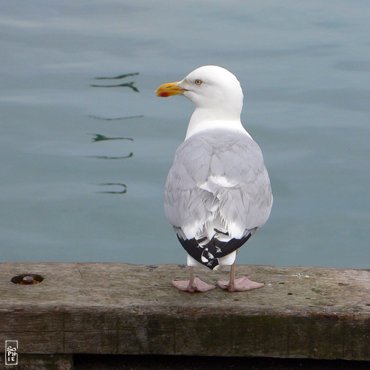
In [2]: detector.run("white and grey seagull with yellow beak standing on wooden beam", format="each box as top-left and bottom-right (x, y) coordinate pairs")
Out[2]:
(156, 65), (273, 293)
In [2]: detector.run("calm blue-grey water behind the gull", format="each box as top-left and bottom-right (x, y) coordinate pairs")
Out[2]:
(0, 0), (370, 268)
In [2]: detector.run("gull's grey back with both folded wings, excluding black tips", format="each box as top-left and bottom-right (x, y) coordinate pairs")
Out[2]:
(165, 132), (272, 239)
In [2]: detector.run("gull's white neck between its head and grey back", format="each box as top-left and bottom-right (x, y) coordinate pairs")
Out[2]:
(185, 108), (249, 140)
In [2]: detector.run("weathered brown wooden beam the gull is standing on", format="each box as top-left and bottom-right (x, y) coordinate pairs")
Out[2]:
(0, 263), (370, 361)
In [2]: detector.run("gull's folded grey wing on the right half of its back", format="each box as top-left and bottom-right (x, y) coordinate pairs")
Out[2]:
(209, 137), (272, 237)
